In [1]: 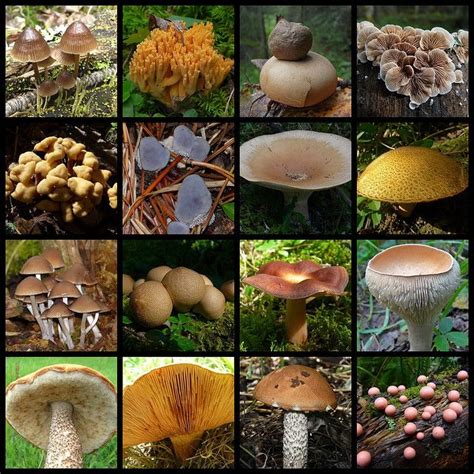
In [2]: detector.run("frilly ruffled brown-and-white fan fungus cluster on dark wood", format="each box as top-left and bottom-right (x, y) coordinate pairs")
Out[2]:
(357, 21), (469, 110)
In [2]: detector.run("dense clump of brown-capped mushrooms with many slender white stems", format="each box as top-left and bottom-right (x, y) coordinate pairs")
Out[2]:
(14, 248), (109, 350)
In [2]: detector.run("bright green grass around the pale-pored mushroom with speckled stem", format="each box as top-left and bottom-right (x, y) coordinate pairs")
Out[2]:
(5, 357), (117, 469)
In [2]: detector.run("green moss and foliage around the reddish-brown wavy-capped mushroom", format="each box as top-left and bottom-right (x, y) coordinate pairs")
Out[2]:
(240, 240), (351, 351)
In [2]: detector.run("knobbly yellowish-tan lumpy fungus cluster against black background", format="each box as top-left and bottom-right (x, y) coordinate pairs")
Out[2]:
(5, 136), (117, 225)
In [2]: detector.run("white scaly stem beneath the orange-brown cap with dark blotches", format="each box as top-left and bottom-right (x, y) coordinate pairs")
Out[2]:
(283, 411), (308, 469)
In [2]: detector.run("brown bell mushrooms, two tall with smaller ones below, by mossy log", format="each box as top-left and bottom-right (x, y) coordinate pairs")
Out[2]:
(11, 21), (97, 103)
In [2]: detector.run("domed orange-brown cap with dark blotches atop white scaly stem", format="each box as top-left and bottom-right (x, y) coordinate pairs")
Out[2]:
(254, 365), (337, 411)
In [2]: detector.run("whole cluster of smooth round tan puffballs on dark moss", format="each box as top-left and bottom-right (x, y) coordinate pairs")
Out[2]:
(122, 265), (234, 328)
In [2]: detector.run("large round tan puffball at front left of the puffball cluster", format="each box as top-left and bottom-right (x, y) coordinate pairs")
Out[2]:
(130, 280), (173, 328)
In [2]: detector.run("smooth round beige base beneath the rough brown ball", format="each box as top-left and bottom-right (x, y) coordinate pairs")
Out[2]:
(260, 51), (337, 107)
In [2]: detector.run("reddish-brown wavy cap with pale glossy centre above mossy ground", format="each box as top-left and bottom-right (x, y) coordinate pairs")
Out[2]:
(243, 260), (349, 300)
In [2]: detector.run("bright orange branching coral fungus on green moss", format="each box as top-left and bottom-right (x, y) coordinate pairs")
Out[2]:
(130, 23), (234, 107)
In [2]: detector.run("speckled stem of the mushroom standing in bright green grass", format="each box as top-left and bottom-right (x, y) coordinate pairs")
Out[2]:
(44, 401), (82, 469)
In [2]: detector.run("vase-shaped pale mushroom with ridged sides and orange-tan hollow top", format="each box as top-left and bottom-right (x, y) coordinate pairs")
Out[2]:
(365, 244), (461, 351)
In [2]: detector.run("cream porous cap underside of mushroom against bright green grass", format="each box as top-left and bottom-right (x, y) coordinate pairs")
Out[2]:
(5, 364), (117, 453)
